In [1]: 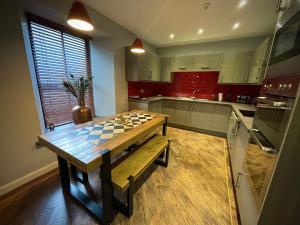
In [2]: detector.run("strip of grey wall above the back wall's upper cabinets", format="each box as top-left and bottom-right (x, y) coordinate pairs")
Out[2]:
(158, 36), (267, 56)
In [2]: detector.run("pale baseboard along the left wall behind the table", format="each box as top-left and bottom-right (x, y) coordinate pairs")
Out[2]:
(0, 162), (58, 196)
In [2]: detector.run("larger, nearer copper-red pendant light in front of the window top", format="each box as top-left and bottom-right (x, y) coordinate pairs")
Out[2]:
(67, 1), (94, 31)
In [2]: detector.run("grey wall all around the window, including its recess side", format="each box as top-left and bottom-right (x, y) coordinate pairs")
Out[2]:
(0, 0), (156, 192)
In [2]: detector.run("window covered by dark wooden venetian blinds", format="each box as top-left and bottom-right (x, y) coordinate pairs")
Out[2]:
(27, 14), (94, 127)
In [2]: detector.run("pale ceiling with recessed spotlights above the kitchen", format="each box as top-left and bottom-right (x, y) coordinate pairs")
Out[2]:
(84, 0), (277, 47)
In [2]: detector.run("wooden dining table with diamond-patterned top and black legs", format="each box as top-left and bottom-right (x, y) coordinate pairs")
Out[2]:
(38, 110), (168, 224)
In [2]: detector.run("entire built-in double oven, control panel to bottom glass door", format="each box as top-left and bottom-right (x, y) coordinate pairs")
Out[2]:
(243, 73), (300, 212)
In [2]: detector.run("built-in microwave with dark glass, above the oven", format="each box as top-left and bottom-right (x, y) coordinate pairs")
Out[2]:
(266, 0), (300, 77)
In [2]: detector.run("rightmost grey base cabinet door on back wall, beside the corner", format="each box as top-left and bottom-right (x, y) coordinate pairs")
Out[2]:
(212, 105), (231, 134)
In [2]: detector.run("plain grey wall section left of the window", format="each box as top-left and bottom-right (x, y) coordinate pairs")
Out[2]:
(0, 1), (55, 186)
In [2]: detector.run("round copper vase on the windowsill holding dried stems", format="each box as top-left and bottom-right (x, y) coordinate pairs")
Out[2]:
(72, 98), (93, 124)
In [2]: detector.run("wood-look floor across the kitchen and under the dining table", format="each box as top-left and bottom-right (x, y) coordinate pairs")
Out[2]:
(0, 128), (237, 225)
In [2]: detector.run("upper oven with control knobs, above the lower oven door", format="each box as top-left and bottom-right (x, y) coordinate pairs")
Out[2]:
(253, 73), (300, 150)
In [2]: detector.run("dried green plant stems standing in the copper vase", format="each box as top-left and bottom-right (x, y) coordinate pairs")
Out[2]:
(61, 74), (92, 105)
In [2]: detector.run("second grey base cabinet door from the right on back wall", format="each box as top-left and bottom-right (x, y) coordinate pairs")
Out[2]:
(190, 102), (214, 130)
